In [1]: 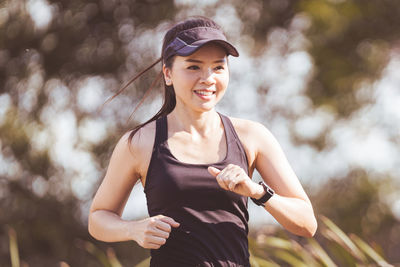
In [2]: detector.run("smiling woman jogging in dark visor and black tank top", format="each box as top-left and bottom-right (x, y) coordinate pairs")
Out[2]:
(89, 17), (317, 266)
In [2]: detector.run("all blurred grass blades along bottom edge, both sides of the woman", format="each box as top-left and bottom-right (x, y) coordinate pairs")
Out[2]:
(8, 216), (400, 267)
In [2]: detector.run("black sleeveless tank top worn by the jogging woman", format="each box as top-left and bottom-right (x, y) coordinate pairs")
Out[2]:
(144, 114), (250, 267)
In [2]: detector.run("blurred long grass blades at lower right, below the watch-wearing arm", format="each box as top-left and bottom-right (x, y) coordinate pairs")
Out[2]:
(250, 216), (391, 267)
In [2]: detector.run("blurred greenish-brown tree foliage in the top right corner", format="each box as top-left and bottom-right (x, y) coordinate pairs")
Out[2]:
(298, 0), (400, 116)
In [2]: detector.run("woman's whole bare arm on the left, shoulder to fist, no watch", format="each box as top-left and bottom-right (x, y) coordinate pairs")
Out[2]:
(89, 128), (179, 249)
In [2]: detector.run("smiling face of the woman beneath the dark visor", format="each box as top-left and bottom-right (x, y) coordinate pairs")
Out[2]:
(163, 43), (229, 112)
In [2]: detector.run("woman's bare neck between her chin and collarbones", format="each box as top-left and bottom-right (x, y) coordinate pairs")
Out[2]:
(168, 108), (221, 137)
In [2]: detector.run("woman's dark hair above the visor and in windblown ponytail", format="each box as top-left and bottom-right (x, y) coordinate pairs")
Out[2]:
(124, 16), (221, 144)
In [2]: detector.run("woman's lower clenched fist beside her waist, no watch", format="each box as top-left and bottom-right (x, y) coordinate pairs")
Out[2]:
(133, 215), (179, 249)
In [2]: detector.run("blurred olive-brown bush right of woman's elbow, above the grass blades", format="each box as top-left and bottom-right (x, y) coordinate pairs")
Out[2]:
(311, 170), (400, 258)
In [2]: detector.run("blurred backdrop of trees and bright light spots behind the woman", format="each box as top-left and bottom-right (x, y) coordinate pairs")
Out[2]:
(0, 0), (400, 266)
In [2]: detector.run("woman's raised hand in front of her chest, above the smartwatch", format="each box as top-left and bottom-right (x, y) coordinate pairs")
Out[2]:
(208, 164), (264, 198)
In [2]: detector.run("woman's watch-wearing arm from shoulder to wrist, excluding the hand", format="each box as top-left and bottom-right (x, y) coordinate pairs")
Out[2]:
(252, 123), (317, 237)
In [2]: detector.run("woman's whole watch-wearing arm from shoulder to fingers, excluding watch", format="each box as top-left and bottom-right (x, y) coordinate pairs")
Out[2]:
(209, 120), (317, 237)
